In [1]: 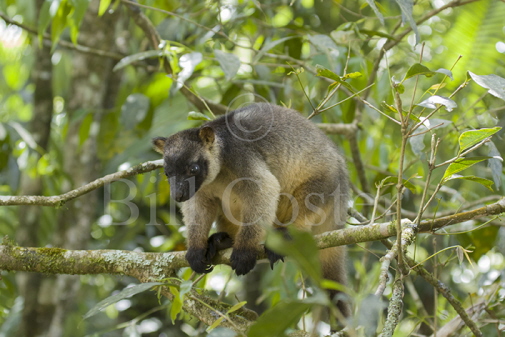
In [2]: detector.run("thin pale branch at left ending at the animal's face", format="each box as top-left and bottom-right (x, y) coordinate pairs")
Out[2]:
(0, 159), (163, 207)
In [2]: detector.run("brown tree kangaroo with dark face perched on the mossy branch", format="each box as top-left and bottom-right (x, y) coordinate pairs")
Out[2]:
(153, 104), (349, 316)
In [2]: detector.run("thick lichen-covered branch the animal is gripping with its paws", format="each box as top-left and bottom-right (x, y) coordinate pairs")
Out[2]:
(0, 198), (505, 278)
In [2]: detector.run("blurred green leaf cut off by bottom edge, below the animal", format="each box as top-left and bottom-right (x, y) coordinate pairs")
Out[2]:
(247, 300), (314, 337)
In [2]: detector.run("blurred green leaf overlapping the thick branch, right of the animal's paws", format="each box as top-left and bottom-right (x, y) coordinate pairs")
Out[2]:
(266, 229), (322, 284)
